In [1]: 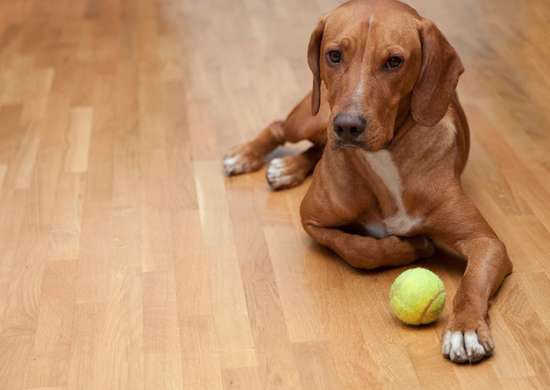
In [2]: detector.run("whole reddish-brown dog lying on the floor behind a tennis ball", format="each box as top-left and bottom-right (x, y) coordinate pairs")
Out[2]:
(224, 0), (512, 363)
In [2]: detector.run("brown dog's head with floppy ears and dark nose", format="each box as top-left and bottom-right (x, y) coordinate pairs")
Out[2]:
(308, 0), (464, 151)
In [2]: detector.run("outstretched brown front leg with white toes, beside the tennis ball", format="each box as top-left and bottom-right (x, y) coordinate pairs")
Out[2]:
(433, 195), (512, 363)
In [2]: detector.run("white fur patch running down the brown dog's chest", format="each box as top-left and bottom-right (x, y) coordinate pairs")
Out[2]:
(364, 150), (422, 235)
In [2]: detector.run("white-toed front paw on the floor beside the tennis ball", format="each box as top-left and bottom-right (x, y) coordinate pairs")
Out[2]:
(441, 320), (495, 363)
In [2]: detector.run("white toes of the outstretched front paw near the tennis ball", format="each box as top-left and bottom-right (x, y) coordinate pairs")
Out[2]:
(441, 330), (492, 363)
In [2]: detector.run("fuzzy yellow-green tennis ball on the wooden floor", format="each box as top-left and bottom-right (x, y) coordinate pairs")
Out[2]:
(390, 268), (446, 325)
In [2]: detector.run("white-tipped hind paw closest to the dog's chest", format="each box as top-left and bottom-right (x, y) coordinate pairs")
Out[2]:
(266, 155), (310, 190)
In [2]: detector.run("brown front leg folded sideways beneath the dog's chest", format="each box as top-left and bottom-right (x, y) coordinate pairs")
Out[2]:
(304, 224), (434, 269)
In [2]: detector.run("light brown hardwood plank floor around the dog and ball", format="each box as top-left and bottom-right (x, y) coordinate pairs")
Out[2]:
(0, 0), (550, 390)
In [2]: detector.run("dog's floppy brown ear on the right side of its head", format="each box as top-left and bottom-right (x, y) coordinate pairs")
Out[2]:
(411, 19), (464, 126)
